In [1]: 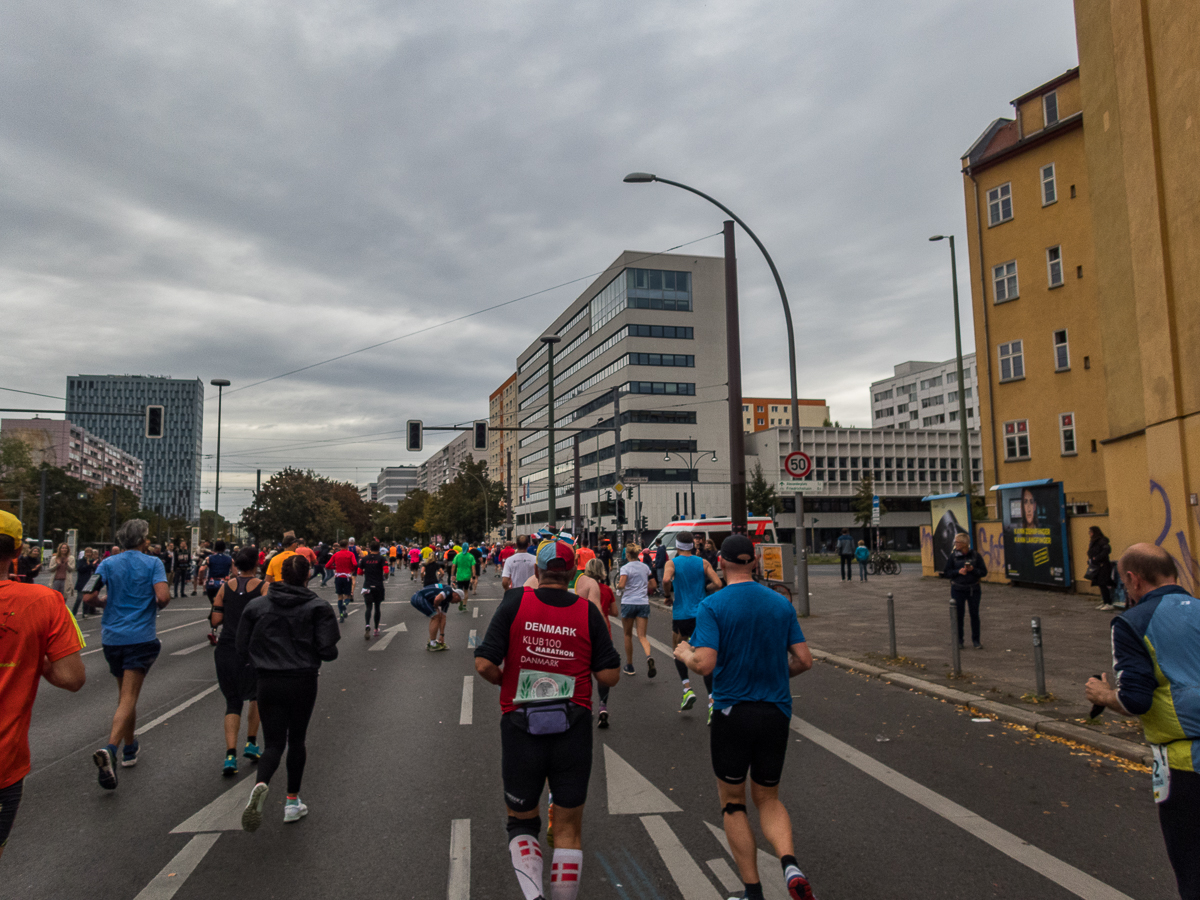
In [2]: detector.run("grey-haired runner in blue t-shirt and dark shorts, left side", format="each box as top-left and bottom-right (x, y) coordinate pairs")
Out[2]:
(83, 518), (170, 791)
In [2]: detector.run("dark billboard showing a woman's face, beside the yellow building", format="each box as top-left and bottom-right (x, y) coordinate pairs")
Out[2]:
(997, 481), (1070, 588)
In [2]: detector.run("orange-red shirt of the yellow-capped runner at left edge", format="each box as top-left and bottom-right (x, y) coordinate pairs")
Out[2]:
(0, 581), (84, 787)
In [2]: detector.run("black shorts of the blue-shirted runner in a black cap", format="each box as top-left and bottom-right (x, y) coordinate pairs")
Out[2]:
(709, 702), (791, 787)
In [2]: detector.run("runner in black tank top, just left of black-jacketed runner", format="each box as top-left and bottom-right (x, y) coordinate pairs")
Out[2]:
(210, 547), (265, 775)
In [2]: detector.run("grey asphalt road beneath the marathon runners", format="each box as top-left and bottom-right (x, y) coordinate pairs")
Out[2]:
(0, 575), (1176, 900)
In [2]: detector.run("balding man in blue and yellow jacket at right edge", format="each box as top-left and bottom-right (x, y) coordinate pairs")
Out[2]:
(1085, 544), (1200, 900)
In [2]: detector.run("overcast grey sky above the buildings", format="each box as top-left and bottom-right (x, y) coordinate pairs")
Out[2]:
(0, 0), (1076, 514)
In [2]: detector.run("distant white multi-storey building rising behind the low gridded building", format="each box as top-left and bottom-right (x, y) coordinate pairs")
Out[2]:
(871, 353), (979, 430)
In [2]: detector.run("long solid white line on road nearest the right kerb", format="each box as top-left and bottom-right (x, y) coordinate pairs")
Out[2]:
(792, 716), (1132, 900)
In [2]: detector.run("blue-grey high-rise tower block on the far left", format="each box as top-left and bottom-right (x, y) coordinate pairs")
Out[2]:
(66, 374), (204, 522)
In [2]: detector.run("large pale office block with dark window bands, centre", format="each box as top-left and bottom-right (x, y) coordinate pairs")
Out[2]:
(514, 251), (728, 532)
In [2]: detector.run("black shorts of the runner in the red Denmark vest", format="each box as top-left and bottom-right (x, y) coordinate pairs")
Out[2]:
(500, 708), (592, 812)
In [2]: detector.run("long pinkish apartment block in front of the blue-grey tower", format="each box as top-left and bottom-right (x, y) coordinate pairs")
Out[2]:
(0, 419), (143, 498)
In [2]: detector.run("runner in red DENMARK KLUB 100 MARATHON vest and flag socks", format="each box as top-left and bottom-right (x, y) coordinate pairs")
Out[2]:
(475, 540), (620, 900)
